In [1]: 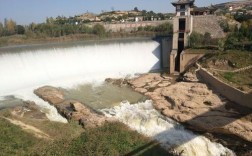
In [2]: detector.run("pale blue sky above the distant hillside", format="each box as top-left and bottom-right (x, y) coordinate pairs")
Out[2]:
(0, 0), (234, 25)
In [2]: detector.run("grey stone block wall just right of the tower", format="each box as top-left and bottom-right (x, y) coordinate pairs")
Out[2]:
(193, 15), (225, 38)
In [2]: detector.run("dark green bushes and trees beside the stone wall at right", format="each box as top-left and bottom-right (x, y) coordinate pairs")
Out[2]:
(189, 15), (252, 51)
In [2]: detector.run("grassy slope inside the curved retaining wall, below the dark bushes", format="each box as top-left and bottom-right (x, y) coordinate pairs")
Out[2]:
(200, 50), (252, 92)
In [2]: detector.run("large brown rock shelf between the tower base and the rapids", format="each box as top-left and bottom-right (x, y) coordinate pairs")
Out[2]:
(128, 73), (252, 142)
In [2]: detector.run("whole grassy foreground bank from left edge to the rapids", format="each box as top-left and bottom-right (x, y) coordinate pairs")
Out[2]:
(0, 110), (170, 156)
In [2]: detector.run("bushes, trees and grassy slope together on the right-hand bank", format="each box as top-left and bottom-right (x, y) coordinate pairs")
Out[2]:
(188, 14), (252, 91)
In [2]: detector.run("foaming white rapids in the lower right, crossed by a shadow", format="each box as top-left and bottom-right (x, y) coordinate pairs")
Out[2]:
(102, 100), (235, 156)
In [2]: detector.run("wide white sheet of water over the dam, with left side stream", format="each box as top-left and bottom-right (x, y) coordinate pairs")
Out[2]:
(0, 40), (160, 122)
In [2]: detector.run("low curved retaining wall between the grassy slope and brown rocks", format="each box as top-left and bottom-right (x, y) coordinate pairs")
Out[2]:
(197, 68), (252, 108)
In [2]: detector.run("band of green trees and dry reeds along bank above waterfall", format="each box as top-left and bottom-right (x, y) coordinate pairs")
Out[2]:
(0, 17), (172, 46)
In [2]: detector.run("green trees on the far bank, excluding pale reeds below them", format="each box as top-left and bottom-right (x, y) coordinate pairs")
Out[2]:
(0, 17), (172, 38)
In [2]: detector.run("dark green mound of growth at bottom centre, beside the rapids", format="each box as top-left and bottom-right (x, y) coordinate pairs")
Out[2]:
(32, 123), (169, 156)
